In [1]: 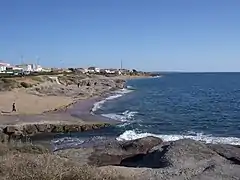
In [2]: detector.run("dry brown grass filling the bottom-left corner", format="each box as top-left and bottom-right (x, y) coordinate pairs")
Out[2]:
(0, 144), (132, 180)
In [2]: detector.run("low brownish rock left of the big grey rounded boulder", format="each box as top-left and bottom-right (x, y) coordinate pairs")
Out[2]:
(55, 137), (162, 166)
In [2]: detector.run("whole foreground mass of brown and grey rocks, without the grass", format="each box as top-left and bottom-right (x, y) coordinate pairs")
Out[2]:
(55, 137), (240, 180)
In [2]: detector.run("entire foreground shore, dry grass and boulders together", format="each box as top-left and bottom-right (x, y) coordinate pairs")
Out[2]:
(0, 136), (240, 180)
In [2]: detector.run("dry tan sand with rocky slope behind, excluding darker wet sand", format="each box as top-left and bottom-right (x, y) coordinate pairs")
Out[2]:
(0, 76), (146, 115)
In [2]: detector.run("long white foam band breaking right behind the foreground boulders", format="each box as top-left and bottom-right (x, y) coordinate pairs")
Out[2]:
(117, 130), (240, 145)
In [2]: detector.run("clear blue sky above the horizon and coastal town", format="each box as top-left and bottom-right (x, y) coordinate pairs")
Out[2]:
(0, 0), (240, 71)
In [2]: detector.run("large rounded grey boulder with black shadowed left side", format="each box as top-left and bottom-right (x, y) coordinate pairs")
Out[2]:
(121, 139), (225, 169)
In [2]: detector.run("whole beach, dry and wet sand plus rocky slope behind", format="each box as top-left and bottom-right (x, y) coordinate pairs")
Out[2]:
(0, 76), (137, 125)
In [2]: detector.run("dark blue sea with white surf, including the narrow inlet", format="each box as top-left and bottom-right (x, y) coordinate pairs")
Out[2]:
(52, 73), (240, 150)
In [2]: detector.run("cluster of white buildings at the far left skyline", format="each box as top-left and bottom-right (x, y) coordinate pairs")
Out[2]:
(0, 61), (49, 74)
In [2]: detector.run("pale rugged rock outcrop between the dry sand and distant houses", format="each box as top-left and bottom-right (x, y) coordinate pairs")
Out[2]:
(27, 75), (126, 99)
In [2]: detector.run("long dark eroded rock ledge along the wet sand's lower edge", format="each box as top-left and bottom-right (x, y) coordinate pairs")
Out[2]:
(0, 123), (110, 142)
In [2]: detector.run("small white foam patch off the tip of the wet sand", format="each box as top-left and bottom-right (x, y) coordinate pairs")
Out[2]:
(102, 110), (137, 122)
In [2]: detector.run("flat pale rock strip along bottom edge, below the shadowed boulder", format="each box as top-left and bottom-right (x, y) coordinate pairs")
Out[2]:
(98, 164), (240, 180)
